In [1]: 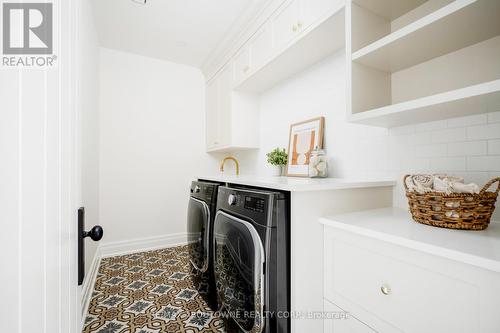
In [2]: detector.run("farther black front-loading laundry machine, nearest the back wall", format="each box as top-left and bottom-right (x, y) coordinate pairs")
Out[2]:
(187, 181), (220, 311)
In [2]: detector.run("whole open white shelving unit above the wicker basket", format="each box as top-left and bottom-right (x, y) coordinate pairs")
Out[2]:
(346, 0), (500, 127)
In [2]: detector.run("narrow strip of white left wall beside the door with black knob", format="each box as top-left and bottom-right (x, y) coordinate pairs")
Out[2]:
(79, 1), (99, 279)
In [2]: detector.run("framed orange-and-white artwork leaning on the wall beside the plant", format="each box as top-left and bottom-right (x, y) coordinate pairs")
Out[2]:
(286, 117), (325, 177)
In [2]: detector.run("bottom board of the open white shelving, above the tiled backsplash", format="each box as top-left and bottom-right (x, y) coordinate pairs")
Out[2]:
(349, 80), (500, 127)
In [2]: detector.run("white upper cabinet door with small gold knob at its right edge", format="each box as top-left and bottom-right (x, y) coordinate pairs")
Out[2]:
(271, 0), (299, 52)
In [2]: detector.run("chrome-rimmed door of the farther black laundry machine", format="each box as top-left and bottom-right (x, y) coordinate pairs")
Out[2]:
(188, 198), (210, 272)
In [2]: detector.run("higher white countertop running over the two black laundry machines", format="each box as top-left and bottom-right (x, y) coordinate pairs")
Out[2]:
(196, 175), (396, 191)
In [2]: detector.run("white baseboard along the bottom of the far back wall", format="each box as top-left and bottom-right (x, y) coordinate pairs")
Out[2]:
(99, 232), (187, 258)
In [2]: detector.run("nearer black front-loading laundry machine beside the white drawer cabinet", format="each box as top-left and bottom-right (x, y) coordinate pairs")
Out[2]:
(214, 186), (290, 333)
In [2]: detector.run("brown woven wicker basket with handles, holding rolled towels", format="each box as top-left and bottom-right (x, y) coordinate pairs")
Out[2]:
(403, 175), (500, 230)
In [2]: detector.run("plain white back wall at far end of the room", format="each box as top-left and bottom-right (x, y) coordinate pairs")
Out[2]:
(99, 49), (220, 243)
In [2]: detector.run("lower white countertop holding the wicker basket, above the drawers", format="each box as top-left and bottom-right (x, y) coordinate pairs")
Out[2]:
(320, 208), (500, 272)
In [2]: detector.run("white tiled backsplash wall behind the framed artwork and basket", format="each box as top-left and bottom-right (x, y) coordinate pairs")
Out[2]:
(238, 51), (500, 219)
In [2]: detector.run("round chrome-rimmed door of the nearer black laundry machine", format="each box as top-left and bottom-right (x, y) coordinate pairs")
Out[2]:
(214, 211), (264, 333)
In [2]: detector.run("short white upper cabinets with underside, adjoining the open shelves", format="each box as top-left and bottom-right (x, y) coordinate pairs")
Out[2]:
(234, 0), (345, 93)
